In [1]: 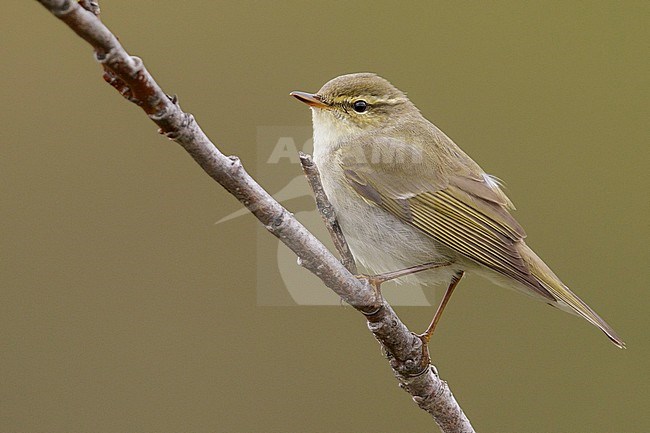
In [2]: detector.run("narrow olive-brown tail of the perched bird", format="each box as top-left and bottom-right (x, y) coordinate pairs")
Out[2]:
(520, 244), (625, 349)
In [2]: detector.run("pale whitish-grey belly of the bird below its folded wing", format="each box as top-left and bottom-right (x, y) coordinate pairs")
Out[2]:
(323, 172), (458, 284)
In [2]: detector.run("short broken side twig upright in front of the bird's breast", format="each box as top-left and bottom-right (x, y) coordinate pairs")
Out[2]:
(299, 152), (357, 274)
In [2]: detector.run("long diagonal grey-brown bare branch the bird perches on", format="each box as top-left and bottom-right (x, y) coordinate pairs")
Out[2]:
(38, 0), (474, 433)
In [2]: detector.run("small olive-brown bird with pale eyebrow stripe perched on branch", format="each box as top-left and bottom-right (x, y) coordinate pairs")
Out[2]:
(291, 73), (625, 348)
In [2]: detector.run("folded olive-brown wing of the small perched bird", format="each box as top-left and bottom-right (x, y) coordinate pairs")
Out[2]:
(344, 165), (555, 300)
